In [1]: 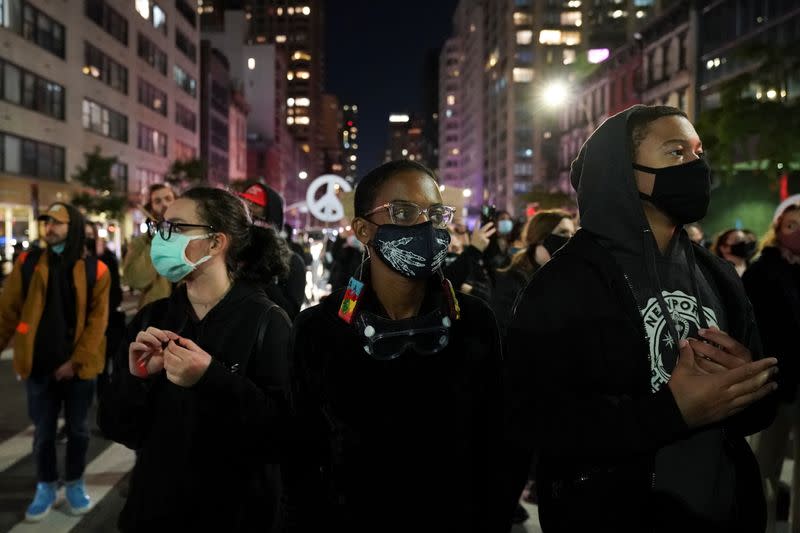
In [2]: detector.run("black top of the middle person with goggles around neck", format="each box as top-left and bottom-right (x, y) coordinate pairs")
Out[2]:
(288, 282), (505, 533)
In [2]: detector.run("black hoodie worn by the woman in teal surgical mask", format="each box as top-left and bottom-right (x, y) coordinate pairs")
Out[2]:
(98, 282), (290, 532)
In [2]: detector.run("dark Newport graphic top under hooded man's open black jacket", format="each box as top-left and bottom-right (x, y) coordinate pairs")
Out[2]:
(617, 240), (735, 525)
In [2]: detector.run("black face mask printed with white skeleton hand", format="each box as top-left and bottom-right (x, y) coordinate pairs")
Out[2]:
(372, 222), (450, 279)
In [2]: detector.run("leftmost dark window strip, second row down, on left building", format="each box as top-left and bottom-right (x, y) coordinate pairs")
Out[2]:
(0, 59), (64, 120)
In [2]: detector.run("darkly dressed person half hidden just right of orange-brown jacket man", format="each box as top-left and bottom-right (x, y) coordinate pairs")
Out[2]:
(86, 220), (125, 396)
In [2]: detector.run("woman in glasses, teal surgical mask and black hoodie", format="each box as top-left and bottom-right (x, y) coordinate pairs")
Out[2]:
(98, 188), (290, 532)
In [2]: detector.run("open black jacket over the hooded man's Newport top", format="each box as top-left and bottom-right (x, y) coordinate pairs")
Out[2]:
(507, 230), (775, 533)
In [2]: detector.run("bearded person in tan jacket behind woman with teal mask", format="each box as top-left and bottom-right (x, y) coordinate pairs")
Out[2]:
(122, 183), (176, 309)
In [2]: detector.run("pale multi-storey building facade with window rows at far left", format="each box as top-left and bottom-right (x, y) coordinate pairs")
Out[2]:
(0, 0), (199, 254)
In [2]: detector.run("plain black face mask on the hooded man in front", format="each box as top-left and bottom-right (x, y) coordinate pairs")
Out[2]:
(633, 158), (711, 225)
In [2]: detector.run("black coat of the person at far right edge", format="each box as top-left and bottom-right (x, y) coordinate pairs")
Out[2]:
(742, 247), (800, 402)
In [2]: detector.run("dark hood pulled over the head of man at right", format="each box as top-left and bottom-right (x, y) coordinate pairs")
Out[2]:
(570, 105), (650, 255)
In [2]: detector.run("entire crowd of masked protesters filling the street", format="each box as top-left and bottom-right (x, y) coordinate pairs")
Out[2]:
(0, 102), (800, 533)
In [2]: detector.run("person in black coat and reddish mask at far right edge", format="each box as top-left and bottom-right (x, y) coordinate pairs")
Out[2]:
(742, 204), (800, 533)
